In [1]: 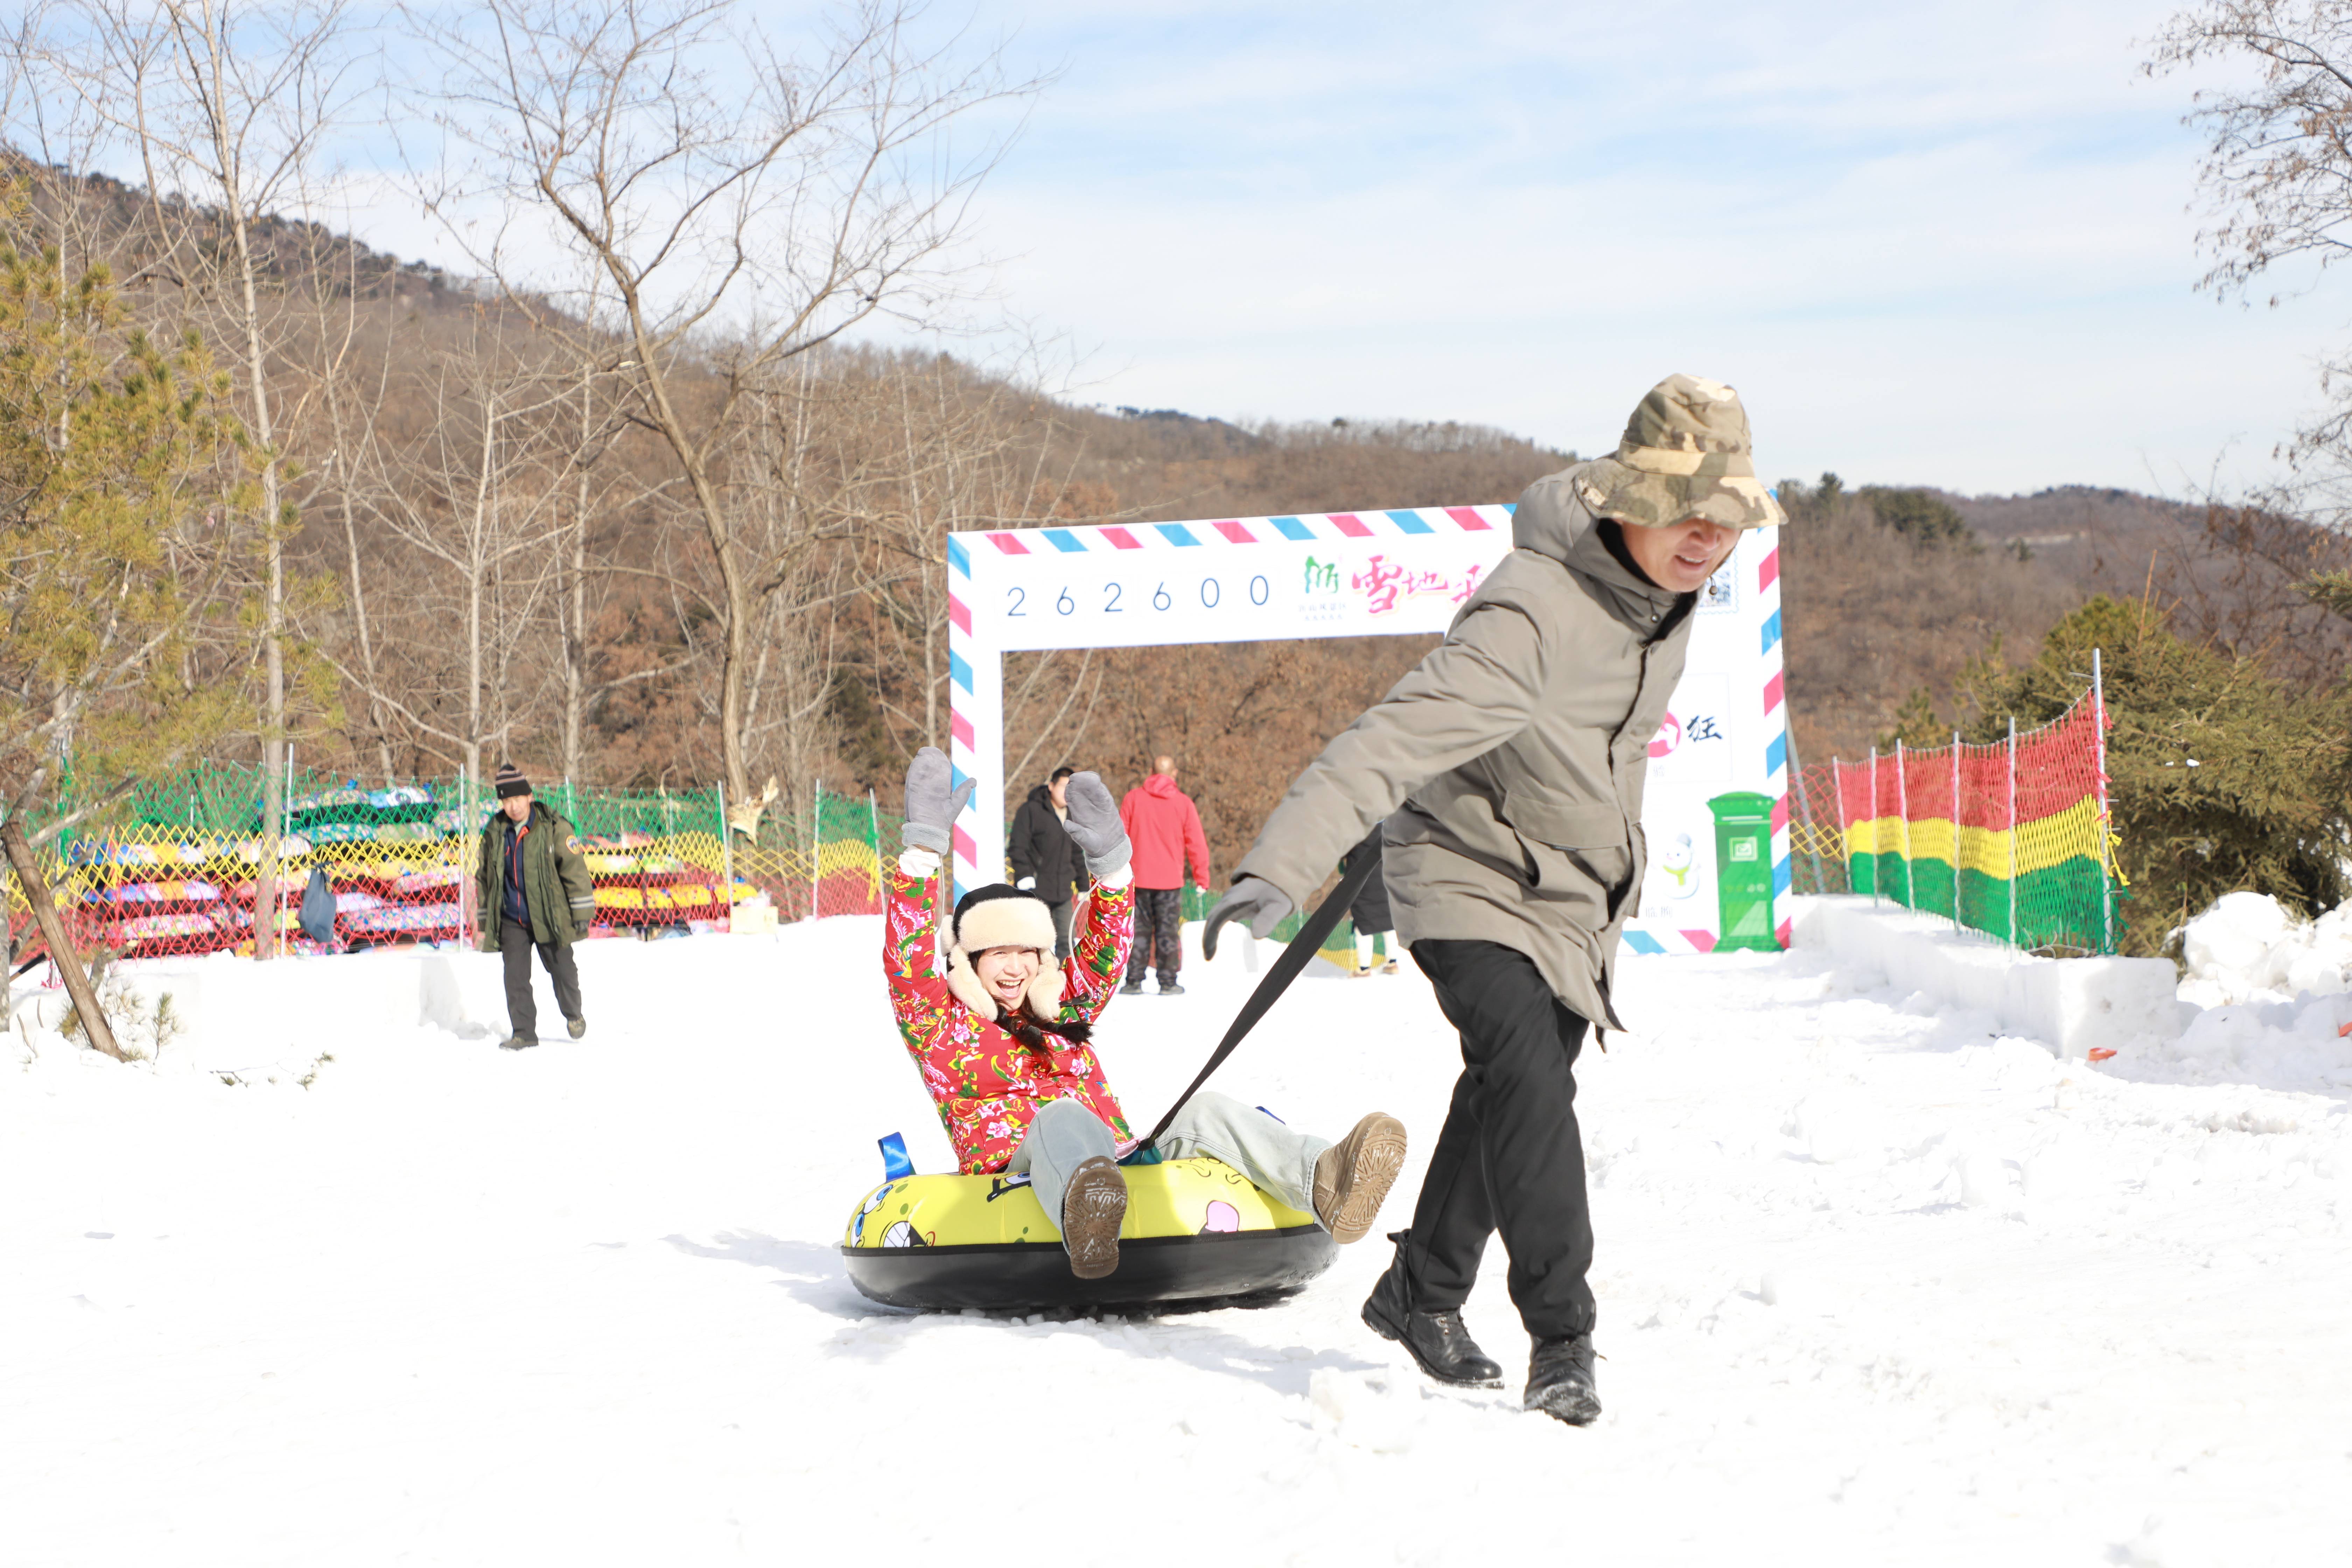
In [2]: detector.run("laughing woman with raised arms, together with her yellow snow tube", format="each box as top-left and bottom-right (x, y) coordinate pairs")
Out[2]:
(842, 745), (1404, 1307)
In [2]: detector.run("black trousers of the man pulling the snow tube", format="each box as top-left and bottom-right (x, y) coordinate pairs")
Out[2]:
(1404, 940), (1592, 1340)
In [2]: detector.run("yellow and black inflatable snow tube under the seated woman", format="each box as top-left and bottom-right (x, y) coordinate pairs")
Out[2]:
(842, 1159), (1338, 1312)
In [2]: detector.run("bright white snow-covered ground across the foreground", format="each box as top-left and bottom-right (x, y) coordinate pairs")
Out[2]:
(0, 919), (2352, 1566)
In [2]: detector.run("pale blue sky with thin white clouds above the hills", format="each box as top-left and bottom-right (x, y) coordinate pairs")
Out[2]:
(341, 0), (2352, 501)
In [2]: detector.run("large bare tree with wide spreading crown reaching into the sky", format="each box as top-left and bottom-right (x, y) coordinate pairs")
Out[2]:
(412, 0), (1035, 797)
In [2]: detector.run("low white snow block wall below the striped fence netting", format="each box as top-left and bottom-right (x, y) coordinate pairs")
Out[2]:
(1792, 896), (2183, 1058)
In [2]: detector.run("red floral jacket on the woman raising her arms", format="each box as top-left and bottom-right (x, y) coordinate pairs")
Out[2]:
(882, 863), (1136, 1175)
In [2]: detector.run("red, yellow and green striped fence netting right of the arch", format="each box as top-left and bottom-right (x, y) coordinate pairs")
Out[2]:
(1816, 689), (2119, 952)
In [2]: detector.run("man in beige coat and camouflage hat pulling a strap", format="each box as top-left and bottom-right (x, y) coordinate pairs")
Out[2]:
(1202, 376), (1783, 1424)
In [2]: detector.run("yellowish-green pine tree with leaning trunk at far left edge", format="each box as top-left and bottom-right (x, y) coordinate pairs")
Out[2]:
(0, 186), (245, 1058)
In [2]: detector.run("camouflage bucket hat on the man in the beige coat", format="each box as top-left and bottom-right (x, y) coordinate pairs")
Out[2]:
(1576, 376), (1787, 529)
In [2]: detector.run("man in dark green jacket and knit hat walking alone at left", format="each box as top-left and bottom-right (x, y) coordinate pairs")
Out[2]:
(480, 762), (595, 1051)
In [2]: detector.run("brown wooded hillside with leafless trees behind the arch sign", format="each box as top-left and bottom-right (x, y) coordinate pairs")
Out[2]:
(0, 164), (2347, 870)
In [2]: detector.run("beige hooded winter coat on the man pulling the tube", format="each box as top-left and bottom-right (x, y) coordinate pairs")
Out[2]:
(1239, 465), (1693, 1027)
